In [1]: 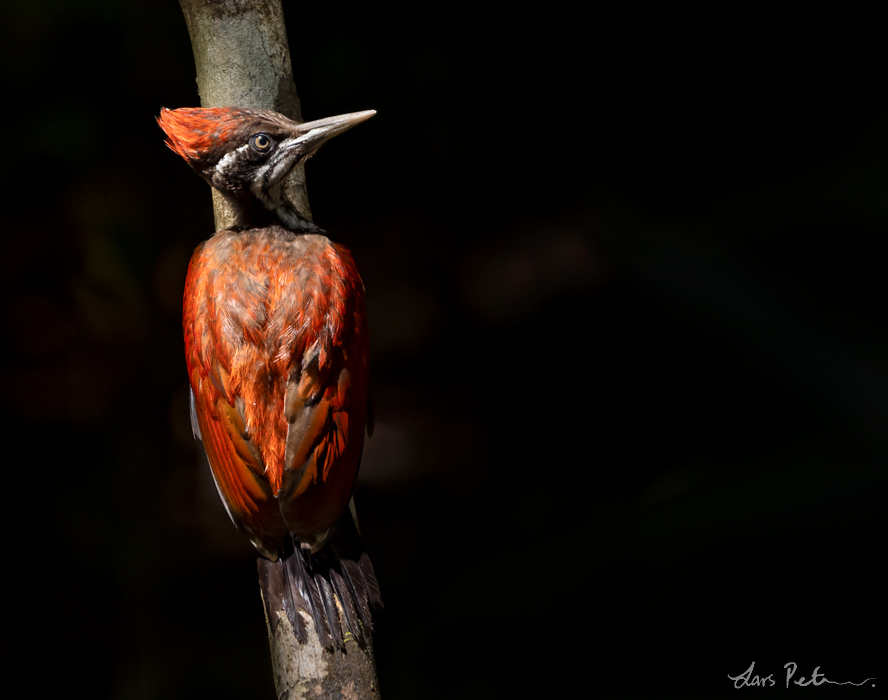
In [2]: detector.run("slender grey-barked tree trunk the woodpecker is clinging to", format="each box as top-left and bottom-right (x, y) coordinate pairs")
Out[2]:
(180, 0), (379, 700)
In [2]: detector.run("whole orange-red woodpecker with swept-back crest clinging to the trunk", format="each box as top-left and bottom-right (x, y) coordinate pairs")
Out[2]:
(158, 107), (381, 649)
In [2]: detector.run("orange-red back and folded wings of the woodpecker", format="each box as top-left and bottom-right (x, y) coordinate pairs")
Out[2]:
(184, 227), (367, 559)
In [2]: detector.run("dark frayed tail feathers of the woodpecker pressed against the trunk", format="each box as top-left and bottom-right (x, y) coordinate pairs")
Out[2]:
(259, 510), (382, 651)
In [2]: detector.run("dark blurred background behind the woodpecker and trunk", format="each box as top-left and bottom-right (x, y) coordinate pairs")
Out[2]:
(0, 0), (888, 700)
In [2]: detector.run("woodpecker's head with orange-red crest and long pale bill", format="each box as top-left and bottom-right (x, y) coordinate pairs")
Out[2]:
(157, 107), (376, 231)
